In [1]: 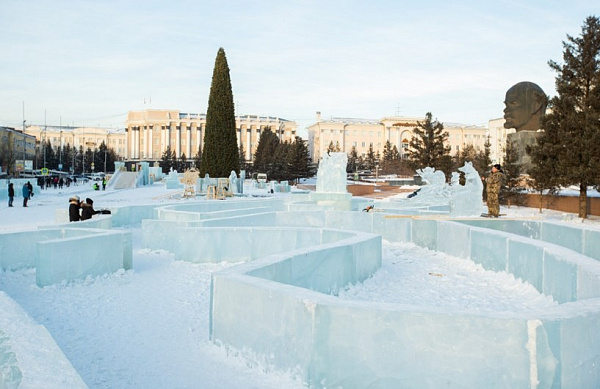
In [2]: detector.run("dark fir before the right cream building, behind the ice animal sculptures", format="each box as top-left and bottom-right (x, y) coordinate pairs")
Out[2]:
(407, 112), (454, 175)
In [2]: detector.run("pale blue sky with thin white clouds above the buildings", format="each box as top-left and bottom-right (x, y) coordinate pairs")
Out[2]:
(0, 0), (600, 133)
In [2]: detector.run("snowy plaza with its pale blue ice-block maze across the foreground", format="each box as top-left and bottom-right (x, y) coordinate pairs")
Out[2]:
(0, 177), (600, 388)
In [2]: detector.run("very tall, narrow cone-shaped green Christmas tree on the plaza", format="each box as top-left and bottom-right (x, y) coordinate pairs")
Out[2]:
(200, 47), (240, 177)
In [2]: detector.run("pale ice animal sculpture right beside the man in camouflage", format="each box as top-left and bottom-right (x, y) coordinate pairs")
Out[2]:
(450, 162), (483, 216)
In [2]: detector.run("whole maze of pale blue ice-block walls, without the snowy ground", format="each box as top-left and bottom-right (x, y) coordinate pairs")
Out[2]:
(0, 194), (600, 389)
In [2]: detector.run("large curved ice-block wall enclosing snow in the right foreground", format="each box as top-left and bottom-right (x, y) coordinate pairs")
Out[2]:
(211, 212), (600, 388)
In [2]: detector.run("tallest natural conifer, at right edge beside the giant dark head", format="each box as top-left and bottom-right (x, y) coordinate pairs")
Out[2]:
(530, 16), (600, 218)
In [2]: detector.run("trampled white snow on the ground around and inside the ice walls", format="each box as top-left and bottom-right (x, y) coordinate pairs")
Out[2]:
(0, 183), (598, 389)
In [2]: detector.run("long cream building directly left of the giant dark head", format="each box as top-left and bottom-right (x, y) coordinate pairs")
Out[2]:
(308, 112), (487, 162)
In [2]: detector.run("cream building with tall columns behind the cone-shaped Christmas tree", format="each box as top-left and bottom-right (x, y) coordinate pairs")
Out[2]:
(125, 109), (298, 161)
